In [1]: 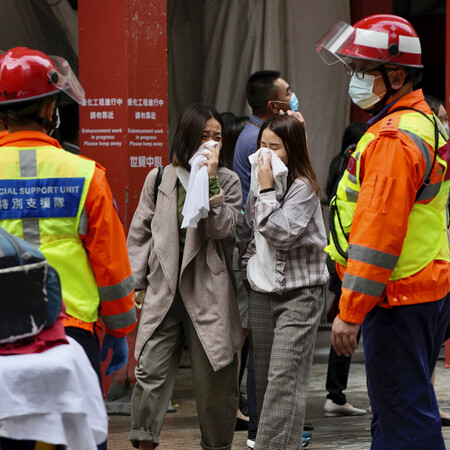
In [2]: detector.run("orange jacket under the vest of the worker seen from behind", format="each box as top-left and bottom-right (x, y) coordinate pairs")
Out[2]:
(0, 131), (136, 337)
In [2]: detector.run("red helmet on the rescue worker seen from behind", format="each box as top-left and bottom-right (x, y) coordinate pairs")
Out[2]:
(0, 47), (84, 107)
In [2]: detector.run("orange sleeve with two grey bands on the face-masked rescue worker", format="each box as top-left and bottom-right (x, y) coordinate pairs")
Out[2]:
(339, 127), (426, 323)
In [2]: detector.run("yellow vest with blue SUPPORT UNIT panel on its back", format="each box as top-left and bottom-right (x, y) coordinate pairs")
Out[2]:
(0, 146), (100, 322)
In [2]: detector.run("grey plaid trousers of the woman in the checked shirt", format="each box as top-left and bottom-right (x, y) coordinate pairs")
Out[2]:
(249, 285), (325, 450)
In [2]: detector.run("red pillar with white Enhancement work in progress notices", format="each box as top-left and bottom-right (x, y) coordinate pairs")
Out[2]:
(78, 0), (168, 393)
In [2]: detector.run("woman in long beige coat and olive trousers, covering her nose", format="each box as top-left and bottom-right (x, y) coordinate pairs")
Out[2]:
(128, 105), (242, 449)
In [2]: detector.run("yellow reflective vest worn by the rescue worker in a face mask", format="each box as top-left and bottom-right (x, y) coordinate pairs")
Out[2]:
(325, 110), (450, 281)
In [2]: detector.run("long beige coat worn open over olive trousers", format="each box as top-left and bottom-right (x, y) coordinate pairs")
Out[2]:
(127, 165), (242, 371)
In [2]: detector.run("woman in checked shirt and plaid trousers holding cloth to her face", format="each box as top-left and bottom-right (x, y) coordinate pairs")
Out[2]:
(241, 115), (328, 450)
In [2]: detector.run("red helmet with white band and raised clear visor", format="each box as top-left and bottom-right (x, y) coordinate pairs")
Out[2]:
(316, 14), (423, 69)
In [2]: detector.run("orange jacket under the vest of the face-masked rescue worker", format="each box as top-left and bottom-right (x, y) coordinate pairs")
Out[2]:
(336, 90), (450, 323)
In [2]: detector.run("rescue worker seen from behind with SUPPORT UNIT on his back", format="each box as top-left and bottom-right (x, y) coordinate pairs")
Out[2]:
(0, 47), (136, 390)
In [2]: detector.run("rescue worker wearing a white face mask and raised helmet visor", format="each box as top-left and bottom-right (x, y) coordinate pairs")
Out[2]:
(316, 15), (450, 450)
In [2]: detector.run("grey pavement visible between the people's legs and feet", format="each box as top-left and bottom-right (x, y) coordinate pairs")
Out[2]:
(108, 327), (450, 450)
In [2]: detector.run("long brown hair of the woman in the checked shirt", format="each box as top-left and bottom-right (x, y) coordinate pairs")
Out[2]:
(257, 115), (320, 199)
